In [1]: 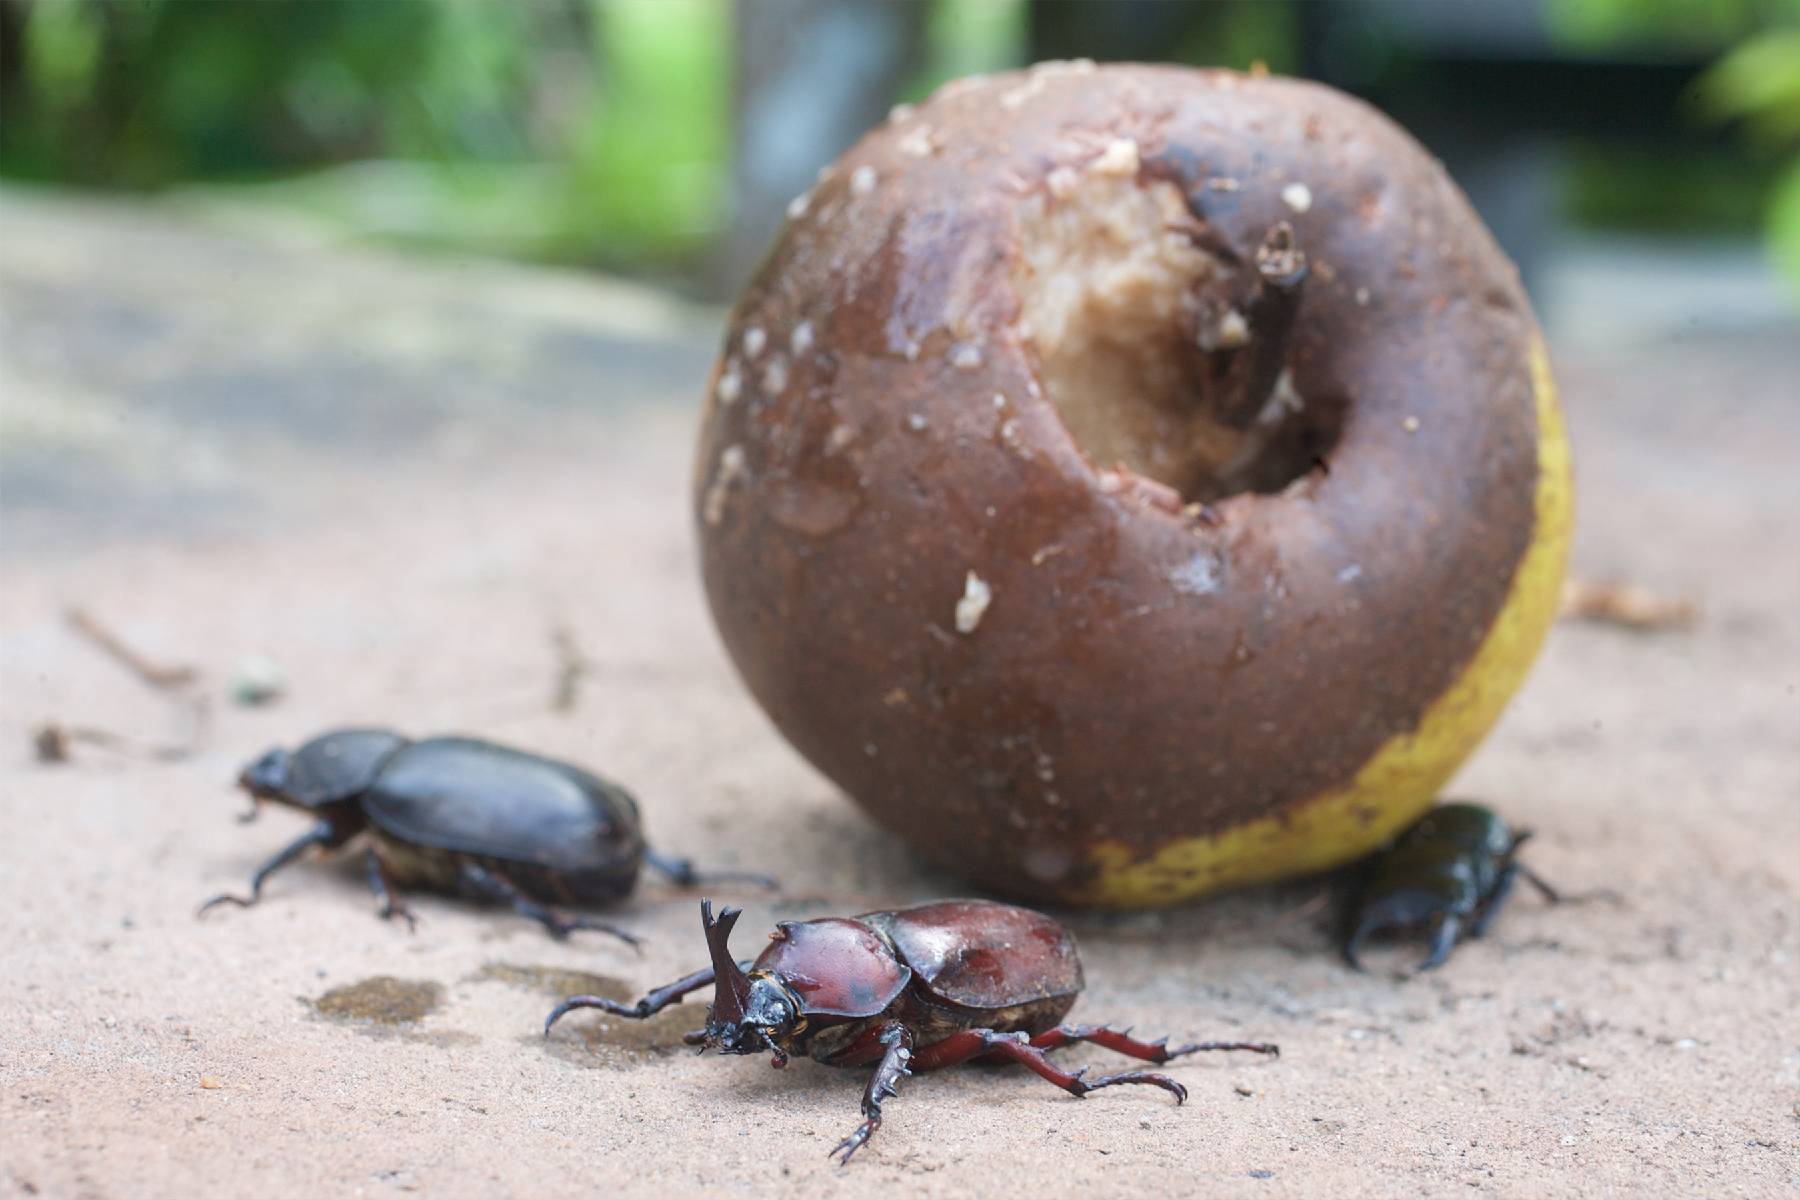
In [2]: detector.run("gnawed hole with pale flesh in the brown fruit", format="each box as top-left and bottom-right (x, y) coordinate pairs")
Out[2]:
(1013, 171), (1345, 502)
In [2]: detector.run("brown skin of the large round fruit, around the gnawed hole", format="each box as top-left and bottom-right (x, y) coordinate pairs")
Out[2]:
(695, 65), (1539, 901)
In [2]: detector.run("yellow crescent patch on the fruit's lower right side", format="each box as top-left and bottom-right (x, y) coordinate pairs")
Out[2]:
(1071, 340), (1573, 909)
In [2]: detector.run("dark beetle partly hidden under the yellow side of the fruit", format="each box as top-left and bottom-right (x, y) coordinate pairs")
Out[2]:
(1343, 804), (1561, 972)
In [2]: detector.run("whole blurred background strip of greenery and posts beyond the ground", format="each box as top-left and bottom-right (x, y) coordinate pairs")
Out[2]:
(0, 0), (1800, 340)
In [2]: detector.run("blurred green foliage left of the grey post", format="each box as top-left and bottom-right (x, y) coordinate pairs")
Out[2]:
(0, 0), (729, 268)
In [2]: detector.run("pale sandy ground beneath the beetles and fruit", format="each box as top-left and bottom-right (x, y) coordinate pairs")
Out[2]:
(0, 196), (1800, 1196)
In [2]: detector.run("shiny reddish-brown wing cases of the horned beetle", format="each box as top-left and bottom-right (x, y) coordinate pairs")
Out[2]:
(860, 900), (1082, 1016)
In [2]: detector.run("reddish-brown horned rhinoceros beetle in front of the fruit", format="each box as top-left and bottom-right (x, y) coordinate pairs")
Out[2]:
(544, 900), (1280, 1162)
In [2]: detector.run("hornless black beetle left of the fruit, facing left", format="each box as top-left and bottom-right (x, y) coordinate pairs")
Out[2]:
(200, 729), (774, 946)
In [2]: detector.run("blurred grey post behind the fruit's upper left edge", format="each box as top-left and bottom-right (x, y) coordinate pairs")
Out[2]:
(713, 0), (929, 295)
